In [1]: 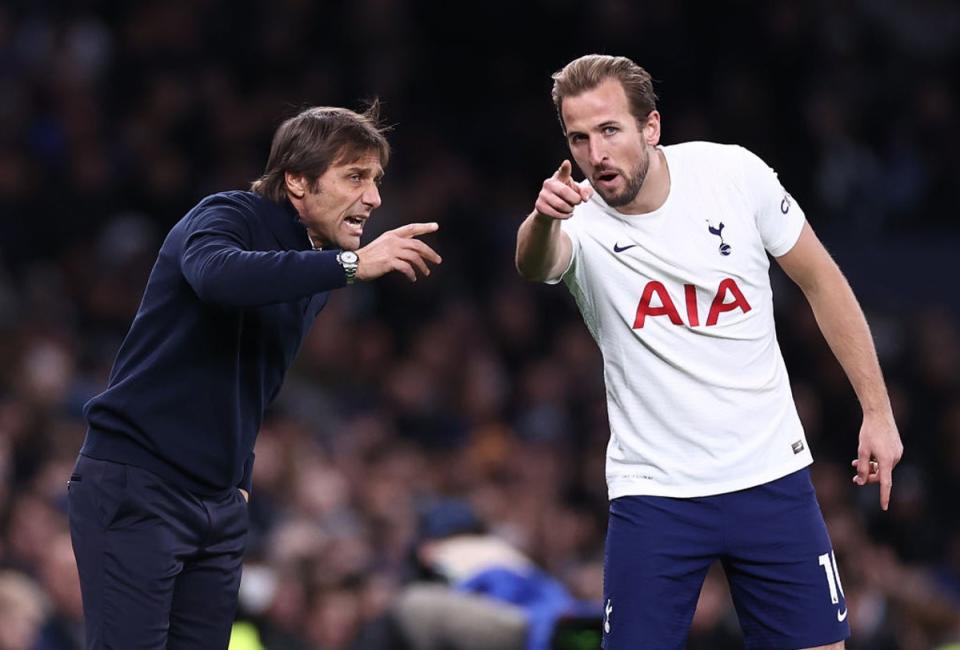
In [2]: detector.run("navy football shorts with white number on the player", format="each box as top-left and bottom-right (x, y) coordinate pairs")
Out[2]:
(603, 469), (850, 650)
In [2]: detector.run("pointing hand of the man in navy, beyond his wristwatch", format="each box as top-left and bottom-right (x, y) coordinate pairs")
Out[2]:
(357, 223), (442, 282)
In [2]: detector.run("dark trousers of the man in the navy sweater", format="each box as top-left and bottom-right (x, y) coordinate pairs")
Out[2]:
(68, 455), (249, 650)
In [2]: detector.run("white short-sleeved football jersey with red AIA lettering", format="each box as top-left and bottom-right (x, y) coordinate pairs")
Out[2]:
(561, 142), (813, 499)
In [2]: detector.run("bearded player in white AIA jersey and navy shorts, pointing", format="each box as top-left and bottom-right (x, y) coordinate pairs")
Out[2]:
(517, 55), (903, 650)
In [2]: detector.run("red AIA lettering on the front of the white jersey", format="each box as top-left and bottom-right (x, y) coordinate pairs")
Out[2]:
(633, 278), (752, 329)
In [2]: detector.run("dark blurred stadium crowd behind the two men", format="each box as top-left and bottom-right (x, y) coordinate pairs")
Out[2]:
(0, 0), (960, 650)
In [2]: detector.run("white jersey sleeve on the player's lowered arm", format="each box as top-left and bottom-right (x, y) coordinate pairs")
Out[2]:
(740, 147), (806, 257)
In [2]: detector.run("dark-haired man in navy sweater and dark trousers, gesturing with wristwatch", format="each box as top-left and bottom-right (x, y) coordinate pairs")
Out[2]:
(69, 104), (440, 650)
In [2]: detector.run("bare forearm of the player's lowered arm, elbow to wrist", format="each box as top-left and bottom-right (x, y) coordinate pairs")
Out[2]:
(803, 265), (890, 415)
